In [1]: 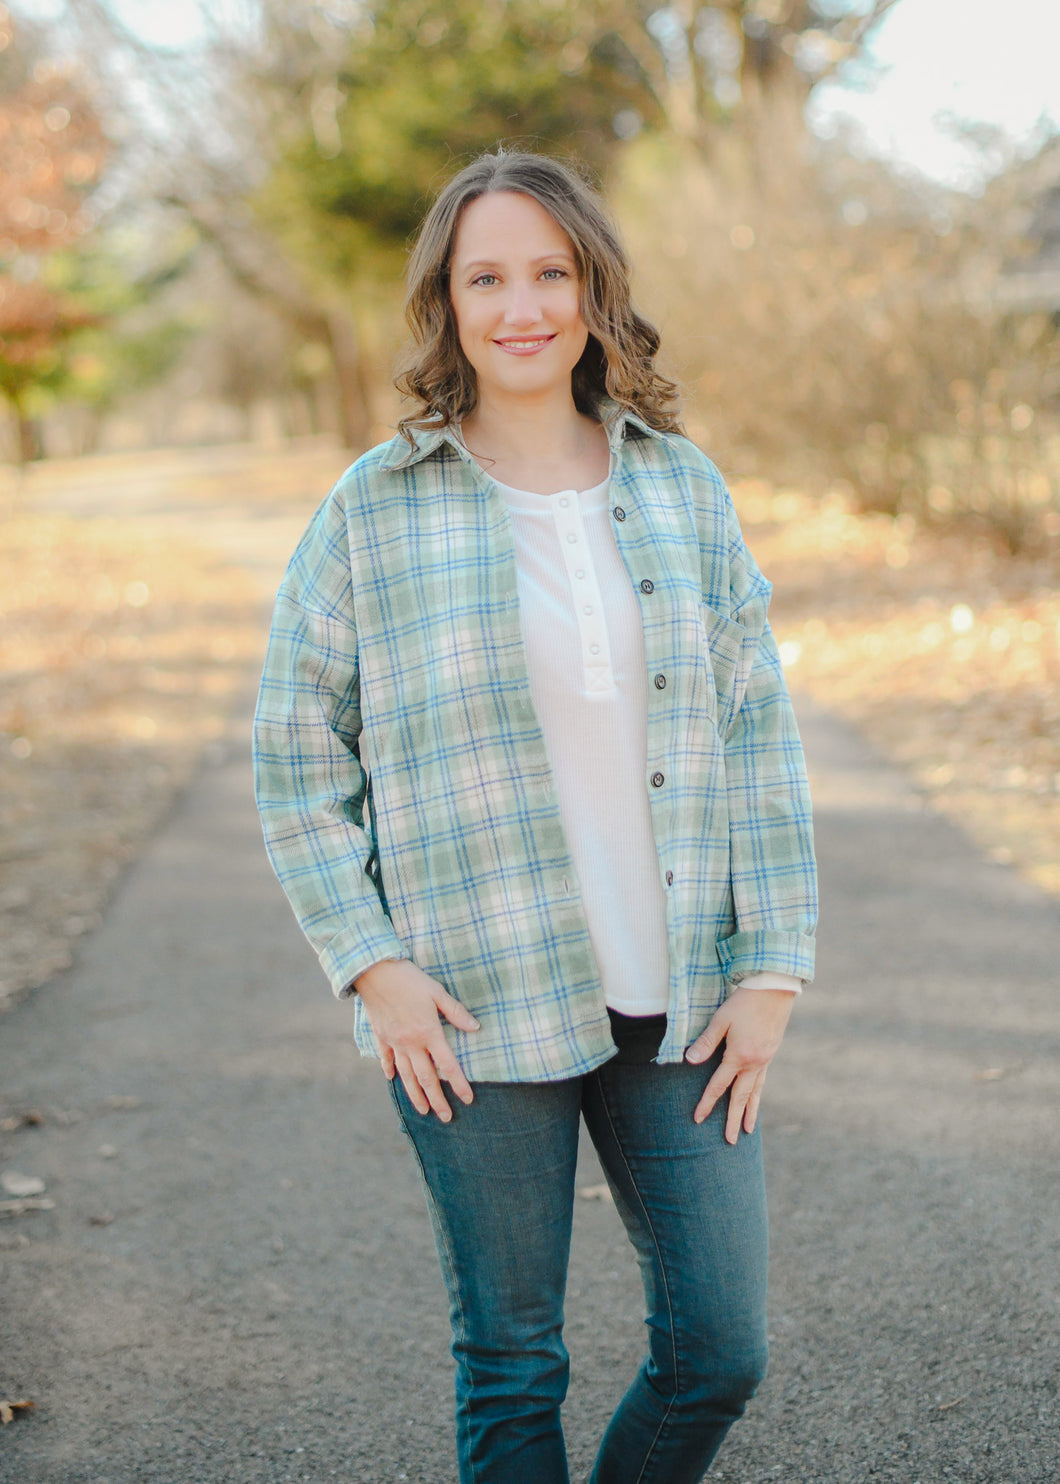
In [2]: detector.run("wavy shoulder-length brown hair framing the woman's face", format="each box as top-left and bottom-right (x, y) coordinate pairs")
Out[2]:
(395, 148), (681, 442)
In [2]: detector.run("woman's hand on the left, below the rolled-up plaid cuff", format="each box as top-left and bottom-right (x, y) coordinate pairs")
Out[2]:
(353, 959), (478, 1123)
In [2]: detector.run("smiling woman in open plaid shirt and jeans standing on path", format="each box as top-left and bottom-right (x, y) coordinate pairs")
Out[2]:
(257, 151), (815, 1484)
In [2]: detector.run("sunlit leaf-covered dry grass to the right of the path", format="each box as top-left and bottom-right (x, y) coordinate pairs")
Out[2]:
(736, 482), (1060, 895)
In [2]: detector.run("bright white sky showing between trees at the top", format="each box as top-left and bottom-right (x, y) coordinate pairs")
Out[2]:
(26, 0), (1060, 188)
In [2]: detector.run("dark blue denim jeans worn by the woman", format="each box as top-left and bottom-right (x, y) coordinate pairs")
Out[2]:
(390, 1014), (768, 1484)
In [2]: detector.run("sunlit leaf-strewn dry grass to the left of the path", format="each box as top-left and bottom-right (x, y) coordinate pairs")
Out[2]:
(0, 502), (261, 1002)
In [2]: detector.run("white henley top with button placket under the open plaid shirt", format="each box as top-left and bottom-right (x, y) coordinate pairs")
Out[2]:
(494, 468), (802, 1015)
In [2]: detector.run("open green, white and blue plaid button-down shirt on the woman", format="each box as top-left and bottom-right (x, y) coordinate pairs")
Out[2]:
(255, 404), (817, 1082)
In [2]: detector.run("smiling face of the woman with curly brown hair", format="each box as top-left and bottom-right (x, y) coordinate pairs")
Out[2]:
(450, 191), (589, 412)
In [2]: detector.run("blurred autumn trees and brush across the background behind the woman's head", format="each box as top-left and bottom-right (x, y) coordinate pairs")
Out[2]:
(0, 0), (1060, 551)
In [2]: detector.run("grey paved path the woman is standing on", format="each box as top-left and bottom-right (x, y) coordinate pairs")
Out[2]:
(0, 638), (1060, 1484)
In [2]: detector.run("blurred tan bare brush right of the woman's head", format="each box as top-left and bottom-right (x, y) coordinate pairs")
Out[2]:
(618, 135), (1060, 554)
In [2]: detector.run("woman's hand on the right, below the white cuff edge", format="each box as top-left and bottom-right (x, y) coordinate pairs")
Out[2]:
(684, 985), (796, 1144)
